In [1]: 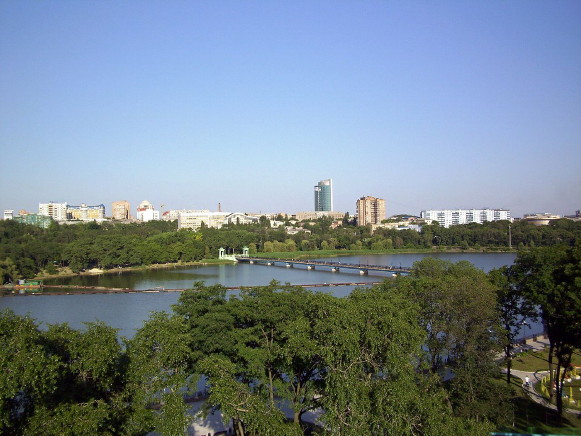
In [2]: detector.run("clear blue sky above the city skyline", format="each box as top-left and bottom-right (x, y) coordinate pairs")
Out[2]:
(0, 0), (581, 216)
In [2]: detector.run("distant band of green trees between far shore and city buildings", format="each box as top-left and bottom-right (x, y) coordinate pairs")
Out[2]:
(0, 218), (581, 283)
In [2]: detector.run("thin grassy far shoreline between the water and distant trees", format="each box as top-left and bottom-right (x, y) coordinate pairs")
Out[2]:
(26, 247), (517, 280)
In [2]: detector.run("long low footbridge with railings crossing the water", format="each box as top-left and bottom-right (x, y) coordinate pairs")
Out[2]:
(236, 256), (411, 275)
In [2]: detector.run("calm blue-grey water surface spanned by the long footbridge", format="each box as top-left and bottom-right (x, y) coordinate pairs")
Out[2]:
(0, 253), (516, 337)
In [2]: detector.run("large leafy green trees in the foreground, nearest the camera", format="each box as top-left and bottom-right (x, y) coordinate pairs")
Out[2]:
(0, 244), (581, 436)
